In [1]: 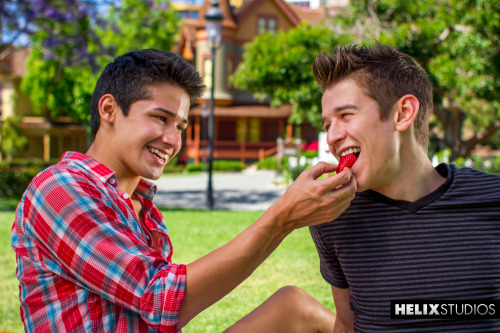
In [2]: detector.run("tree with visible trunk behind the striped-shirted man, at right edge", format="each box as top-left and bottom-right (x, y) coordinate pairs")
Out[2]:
(330, 0), (500, 159)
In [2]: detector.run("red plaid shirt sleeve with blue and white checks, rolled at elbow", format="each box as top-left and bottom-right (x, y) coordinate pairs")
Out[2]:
(12, 160), (186, 332)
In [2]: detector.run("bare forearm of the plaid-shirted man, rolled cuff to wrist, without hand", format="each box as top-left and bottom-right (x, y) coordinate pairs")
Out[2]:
(178, 207), (291, 328)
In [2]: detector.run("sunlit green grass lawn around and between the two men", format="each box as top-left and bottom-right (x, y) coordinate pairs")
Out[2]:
(0, 210), (333, 333)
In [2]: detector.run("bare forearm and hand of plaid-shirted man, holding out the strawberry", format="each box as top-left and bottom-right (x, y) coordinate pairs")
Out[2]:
(177, 163), (356, 328)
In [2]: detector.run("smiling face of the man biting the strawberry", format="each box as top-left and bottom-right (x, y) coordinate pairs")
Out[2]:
(322, 79), (400, 192)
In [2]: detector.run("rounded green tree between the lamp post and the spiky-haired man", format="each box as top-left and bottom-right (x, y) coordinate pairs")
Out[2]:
(232, 23), (349, 128)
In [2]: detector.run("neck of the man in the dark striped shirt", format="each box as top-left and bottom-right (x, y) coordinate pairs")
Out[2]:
(374, 145), (446, 202)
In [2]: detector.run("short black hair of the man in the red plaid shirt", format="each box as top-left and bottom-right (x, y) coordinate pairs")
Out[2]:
(90, 49), (205, 136)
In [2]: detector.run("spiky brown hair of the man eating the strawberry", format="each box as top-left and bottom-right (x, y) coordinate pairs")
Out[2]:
(313, 43), (433, 150)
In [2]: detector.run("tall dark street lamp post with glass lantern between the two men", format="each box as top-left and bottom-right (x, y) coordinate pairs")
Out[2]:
(205, 1), (224, 210)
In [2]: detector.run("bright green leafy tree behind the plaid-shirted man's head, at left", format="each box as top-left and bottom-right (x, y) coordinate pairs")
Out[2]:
(21, 5), (98, 122)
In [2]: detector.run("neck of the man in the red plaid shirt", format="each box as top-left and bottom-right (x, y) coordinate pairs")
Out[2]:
(86, 141), (141, 197)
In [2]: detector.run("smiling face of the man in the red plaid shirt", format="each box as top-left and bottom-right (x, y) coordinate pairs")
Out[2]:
(108, 83), (190, 179)
